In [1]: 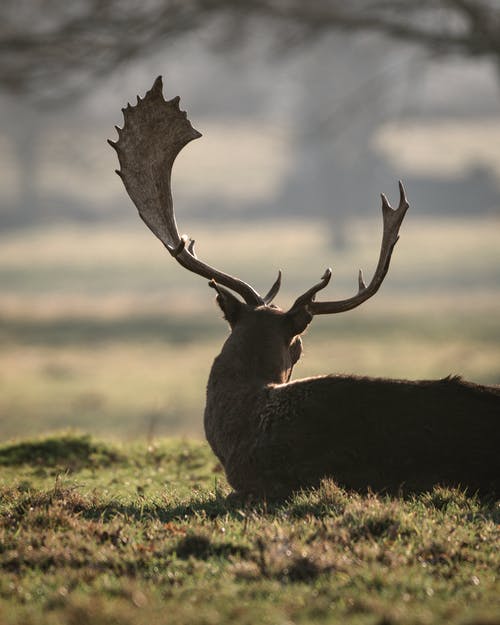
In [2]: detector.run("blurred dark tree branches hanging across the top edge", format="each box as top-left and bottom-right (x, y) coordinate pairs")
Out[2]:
(0, 0), (500, 99)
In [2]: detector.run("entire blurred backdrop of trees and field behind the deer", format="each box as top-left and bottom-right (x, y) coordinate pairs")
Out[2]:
(0, 0), (500, 440)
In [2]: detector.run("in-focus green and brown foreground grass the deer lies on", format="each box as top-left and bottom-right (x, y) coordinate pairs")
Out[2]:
(0, 435), (500, 625)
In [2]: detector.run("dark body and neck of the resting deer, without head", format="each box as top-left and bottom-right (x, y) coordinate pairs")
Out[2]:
(205, 304), (500, 496)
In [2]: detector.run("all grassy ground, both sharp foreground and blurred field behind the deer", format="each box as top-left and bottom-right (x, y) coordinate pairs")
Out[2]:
(0, 219), (500, 625)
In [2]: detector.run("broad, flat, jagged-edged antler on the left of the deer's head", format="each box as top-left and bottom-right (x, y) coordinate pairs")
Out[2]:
(108, 76), (281, 306)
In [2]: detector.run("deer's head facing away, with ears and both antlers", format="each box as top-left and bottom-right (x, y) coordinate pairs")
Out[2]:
(109, 77), (408, 383)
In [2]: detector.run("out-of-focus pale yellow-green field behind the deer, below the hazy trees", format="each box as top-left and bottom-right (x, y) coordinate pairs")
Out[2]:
(0, 214), (500, 440)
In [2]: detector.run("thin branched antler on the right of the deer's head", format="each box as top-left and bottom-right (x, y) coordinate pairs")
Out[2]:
(289, 181), (409, 315)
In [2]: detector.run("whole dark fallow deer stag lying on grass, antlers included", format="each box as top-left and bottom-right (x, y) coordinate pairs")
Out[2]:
(110, 77), (500, 496)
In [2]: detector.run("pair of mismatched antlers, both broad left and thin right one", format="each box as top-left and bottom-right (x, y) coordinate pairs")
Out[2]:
(109, 76), (408, 316)
